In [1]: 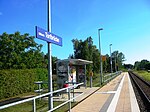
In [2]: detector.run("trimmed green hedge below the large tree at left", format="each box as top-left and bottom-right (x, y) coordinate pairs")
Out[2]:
(0, 69), (47, 100)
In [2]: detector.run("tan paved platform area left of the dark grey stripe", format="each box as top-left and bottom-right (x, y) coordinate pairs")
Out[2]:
(71, 75), (123, 112)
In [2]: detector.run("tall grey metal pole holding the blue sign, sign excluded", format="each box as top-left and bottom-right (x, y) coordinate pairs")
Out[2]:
(47, 0), (53, 110)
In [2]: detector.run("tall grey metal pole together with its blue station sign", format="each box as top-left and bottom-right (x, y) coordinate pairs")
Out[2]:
(36, 0), (62, 110)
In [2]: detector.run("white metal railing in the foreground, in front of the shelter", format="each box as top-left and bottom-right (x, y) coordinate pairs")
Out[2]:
(0, 83), (84, 112)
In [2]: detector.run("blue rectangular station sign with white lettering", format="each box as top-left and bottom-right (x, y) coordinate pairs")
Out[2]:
(36, 26), (62, 46)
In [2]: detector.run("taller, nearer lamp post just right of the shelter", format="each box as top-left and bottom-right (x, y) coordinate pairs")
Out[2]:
(98, 28), (103, 85)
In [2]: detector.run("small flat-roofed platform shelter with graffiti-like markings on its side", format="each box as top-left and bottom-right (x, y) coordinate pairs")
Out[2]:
(56, 59), (93, 89)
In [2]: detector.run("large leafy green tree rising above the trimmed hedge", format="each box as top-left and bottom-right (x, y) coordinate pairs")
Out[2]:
(0, 32), (47, 69)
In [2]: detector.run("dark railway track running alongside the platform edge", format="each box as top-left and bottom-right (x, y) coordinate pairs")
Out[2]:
(129, 71), (150, 112)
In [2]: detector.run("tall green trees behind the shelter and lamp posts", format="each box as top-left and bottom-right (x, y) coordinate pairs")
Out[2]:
(71, 37), (125, 73)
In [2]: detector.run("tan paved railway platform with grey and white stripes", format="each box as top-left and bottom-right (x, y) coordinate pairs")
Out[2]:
(71, 72), (140, 112)
